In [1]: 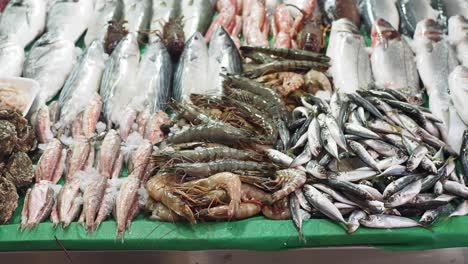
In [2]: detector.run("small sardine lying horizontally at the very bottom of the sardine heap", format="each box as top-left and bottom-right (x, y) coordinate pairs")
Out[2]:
(359, 215), (420, 228)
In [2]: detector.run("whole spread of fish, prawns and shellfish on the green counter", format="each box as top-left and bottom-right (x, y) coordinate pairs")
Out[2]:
(0, 0), (468, 245)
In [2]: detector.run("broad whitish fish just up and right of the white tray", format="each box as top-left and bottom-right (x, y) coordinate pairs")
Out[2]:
(23, 33), (77, 105)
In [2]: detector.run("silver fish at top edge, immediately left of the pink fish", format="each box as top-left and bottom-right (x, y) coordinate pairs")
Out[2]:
(180, 0), (214, 39)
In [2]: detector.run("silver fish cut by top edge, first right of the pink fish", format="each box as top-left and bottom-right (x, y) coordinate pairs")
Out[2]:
(359, 0), (400, 32)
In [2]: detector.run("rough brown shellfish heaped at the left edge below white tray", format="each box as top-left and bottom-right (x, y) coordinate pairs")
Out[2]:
(0, 110), (37, 225)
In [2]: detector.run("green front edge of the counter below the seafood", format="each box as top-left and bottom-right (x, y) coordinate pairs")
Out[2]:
(0, 214), (468, 251)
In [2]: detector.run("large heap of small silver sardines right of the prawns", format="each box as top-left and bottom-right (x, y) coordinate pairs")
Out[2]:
(268, 89), (468, 235)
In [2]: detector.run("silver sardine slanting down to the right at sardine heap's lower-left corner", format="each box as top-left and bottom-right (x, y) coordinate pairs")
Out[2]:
(303, 184), (347, 224)
